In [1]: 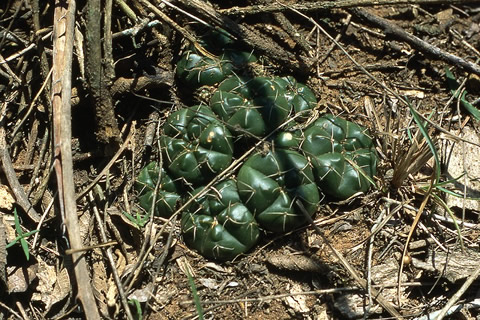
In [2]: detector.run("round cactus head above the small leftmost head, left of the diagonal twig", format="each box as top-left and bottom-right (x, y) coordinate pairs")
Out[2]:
(161, 106), (233, 185)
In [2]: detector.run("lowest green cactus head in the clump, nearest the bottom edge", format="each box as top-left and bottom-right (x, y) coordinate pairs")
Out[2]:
(181, 180), (259, 260)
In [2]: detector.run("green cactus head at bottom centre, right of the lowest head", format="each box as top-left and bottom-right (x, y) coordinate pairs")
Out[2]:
(237, 149), (320, 232)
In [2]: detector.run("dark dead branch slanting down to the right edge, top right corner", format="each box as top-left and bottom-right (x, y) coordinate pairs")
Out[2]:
(350, 8), (480, 75)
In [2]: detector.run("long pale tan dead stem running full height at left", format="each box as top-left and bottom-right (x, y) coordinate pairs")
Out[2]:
(52, 0), (100, 319)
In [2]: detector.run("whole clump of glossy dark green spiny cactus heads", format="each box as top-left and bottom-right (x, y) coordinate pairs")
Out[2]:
(135, 30), (377, 260)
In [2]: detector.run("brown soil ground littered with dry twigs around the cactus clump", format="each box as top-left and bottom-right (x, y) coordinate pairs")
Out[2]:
(0, 0), (480, 319)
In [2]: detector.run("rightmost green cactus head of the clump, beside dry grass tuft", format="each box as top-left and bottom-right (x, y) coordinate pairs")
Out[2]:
(301, 115), (377, 199)
